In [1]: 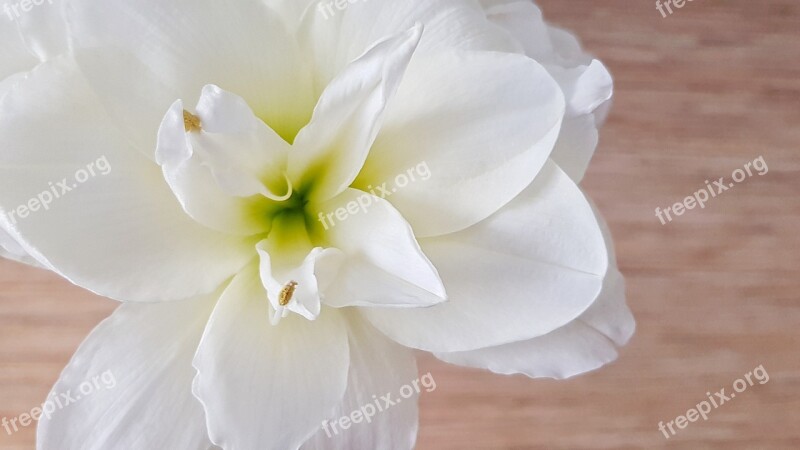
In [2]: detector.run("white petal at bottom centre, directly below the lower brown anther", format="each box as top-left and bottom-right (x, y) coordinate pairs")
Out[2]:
(194, 264), (350, 450)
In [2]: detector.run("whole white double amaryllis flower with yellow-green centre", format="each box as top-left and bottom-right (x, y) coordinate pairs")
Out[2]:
(0, 0), (633, 450)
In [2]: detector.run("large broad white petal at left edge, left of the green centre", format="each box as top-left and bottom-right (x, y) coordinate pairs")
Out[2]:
(0, 60), (255, 301)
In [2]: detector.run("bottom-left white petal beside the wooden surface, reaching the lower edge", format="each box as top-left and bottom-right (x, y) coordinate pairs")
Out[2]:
(37, 295), (217, 450)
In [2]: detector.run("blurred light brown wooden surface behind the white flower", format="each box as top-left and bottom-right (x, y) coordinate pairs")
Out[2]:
(0, 0), (800, 450)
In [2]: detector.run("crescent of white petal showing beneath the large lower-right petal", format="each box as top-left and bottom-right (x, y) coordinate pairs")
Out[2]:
(436, 269), (636, 379)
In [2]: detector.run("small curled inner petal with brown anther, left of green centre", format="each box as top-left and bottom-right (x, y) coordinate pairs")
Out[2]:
(156, 86), (291, 236)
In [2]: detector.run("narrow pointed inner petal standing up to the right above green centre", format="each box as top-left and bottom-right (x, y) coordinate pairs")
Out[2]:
(289, 26), (422, 201)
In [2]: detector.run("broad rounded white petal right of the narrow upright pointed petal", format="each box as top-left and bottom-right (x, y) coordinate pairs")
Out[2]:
(354, 52), (564, 237)
